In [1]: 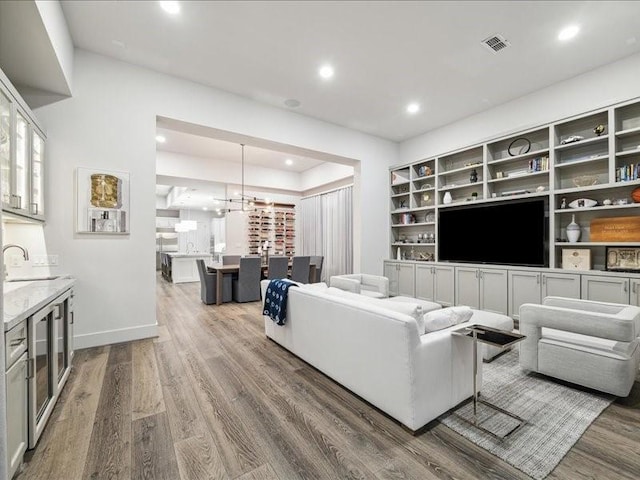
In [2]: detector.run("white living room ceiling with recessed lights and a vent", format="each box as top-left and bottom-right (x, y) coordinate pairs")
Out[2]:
(61, 0), (640, 141)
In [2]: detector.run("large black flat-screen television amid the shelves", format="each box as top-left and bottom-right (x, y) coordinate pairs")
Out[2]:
(438, 198), (549, 267)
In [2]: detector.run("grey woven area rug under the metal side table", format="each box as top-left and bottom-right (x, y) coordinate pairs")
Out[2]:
(440, 349), (615, 480)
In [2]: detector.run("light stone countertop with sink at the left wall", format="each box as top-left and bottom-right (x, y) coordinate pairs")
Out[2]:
(4, 275), (76, 332)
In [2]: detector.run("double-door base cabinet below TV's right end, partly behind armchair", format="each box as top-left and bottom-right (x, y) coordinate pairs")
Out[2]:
(507, 270), (580, 320)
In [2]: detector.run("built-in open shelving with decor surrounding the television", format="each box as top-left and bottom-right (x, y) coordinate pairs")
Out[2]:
(389, 95), (640, 270)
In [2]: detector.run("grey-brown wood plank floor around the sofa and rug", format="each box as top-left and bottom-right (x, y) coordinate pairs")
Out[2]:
(17, 277), (640, 480)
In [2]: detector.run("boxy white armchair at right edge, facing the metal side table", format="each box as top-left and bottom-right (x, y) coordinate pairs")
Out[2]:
(520, 297), (640, 397)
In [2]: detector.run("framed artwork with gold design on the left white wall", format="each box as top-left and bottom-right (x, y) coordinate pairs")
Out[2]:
(76, 167), (130, 235)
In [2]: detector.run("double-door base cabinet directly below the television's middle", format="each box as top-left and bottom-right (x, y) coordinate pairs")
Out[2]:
(455, 267), (508, 315)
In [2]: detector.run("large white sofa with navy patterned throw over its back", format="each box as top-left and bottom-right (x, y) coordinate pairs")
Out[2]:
(262, 280), (482, 432)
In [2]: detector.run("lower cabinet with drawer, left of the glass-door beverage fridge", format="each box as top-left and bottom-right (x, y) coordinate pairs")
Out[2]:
(5, 321), (29, 478)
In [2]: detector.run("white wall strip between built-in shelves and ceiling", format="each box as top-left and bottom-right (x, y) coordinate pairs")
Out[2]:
(398, 54), (640, 163)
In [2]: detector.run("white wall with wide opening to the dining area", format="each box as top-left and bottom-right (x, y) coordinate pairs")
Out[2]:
(36, 50), (398, 348)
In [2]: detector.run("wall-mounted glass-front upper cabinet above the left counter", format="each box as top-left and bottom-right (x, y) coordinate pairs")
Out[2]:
(0, 72), (45, 220)
